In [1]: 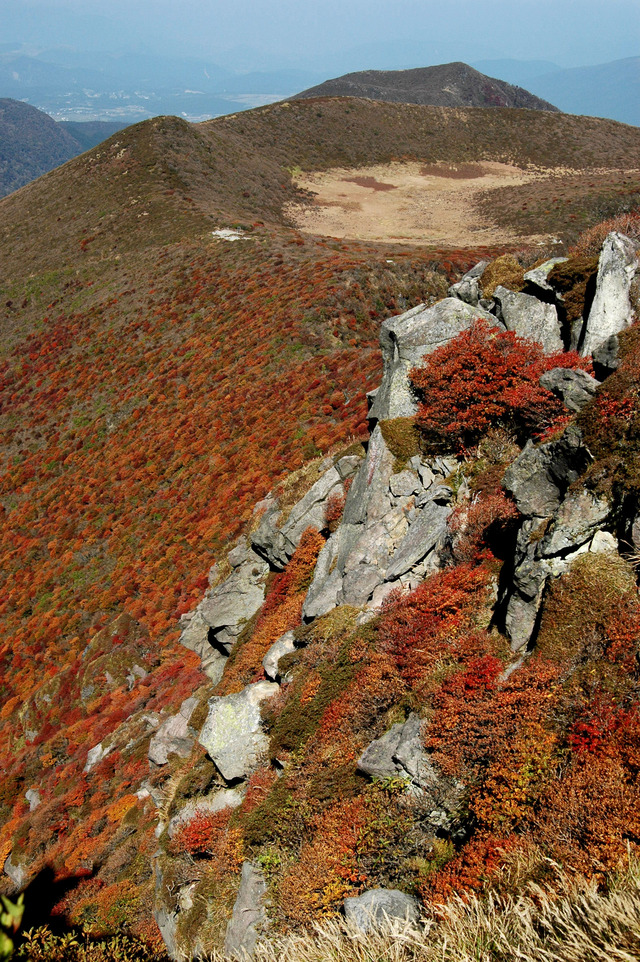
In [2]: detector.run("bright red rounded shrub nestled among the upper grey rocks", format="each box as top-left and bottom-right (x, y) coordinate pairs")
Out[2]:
(410, 320), (587, 451)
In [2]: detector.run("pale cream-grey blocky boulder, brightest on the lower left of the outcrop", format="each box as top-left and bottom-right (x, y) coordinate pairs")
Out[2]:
(198, 681), (280, 782)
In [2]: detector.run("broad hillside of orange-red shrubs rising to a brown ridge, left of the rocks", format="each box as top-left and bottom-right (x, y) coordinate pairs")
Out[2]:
(0, 100), (640, 936)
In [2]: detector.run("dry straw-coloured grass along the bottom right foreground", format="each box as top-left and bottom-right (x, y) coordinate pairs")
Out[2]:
(202, 871), (640, 962)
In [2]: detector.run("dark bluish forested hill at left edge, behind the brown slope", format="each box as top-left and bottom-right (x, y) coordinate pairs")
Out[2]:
(0, 98), (123, 197)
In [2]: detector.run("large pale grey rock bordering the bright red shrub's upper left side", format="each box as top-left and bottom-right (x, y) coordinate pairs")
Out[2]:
(369, 297), (501, 421)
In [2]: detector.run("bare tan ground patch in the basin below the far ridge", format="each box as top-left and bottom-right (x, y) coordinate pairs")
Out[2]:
(286, 161), (608, 247)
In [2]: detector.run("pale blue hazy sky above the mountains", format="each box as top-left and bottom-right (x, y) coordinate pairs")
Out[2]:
(5, 0), (640, 70)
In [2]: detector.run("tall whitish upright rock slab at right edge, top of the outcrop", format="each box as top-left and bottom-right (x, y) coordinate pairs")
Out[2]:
(580, 231), (638, 355)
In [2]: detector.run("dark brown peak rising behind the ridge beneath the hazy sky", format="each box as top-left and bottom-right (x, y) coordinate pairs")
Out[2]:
(296, 63), (558, 111)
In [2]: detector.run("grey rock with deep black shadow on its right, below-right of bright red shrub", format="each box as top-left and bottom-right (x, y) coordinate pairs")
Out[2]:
(503, 425), (591, 518)
